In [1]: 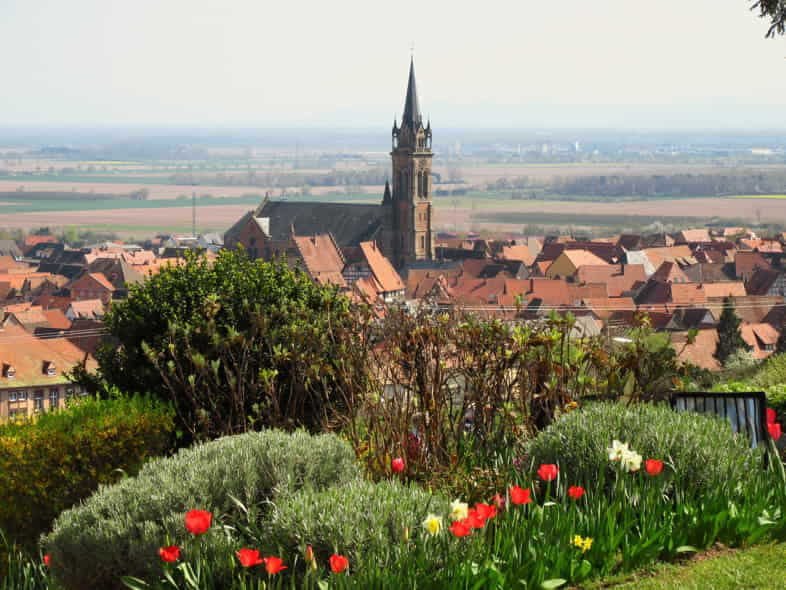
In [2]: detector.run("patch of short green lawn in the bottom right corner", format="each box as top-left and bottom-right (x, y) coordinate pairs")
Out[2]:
(576, 543), (786, 590)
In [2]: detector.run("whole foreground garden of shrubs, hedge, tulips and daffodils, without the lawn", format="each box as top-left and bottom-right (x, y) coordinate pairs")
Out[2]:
(0, 255), (786, 590)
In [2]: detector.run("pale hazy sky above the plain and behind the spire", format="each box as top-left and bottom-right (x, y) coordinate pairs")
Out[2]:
(0, 0), (786, 129)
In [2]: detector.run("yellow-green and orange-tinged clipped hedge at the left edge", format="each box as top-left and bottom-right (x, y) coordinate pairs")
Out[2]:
(0, 397), (173, 548)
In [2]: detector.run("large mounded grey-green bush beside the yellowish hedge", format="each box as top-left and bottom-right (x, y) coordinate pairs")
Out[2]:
(43, 431), (359, 589)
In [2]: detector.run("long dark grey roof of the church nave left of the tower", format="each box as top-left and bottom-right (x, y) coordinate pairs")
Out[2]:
(256, 201), (383, 247)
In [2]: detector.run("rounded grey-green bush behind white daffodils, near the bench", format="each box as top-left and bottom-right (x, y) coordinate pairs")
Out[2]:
(527, 403), (761, 495)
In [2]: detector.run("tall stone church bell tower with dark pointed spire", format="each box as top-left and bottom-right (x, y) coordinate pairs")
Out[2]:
(385, 60), (434, 269)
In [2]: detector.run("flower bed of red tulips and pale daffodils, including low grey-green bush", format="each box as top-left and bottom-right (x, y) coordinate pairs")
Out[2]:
(36, 406), (786, 590)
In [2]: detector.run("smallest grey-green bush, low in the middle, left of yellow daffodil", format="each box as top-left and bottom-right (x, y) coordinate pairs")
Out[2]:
(259, 480), (448, 566)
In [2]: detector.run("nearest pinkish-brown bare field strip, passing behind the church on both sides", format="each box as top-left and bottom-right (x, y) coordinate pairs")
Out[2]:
(0, 194), (786, 237)
